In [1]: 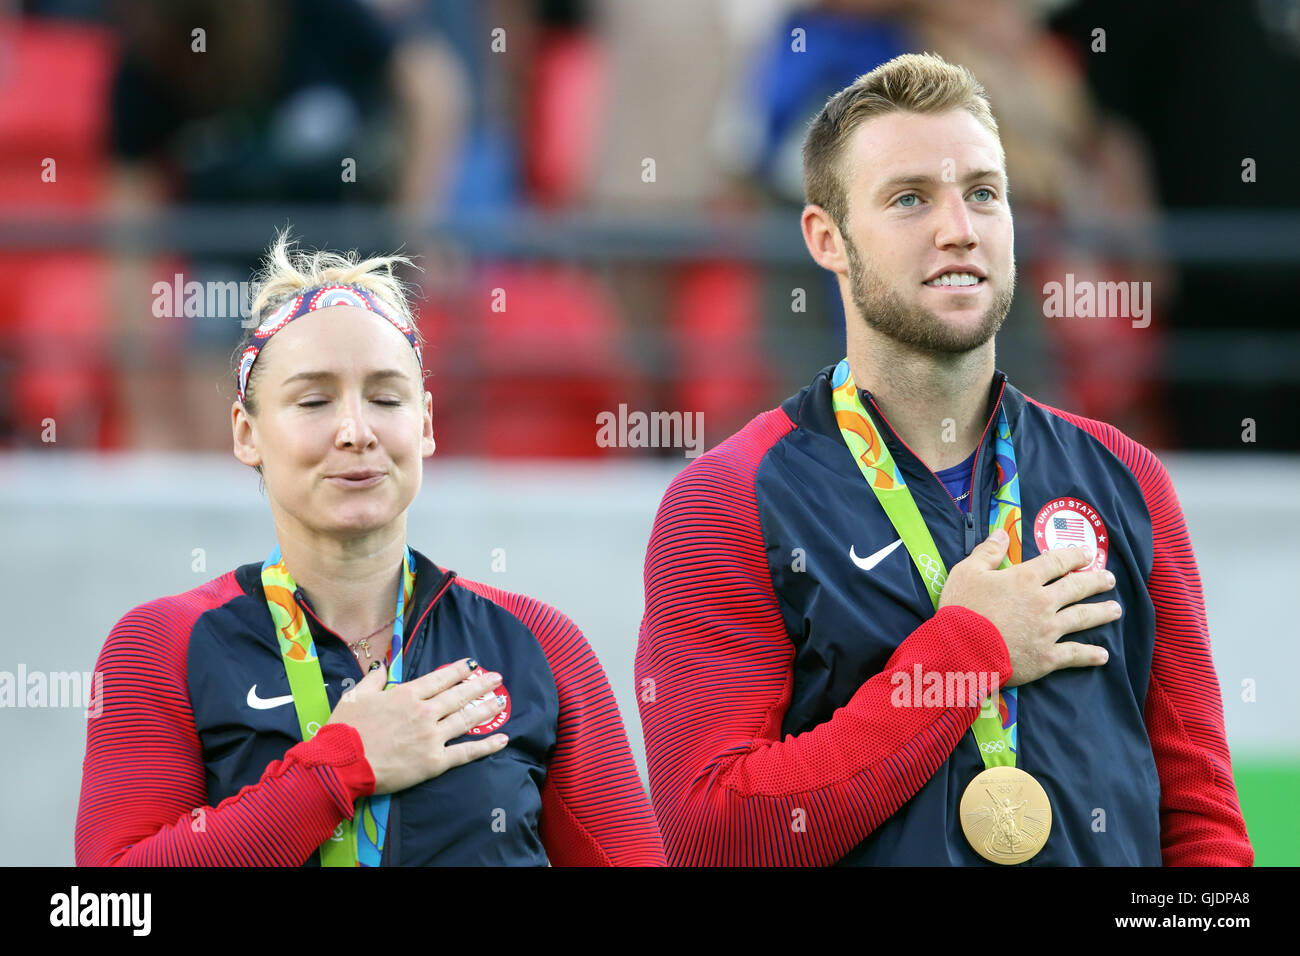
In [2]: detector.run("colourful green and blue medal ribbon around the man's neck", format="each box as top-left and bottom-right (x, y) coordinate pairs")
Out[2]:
(831, 359), (1021, 769)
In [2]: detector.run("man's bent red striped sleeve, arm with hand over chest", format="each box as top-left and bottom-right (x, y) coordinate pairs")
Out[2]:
(636, 410), (1011, 865)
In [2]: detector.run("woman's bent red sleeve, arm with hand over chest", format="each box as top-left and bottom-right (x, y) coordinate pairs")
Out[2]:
(75, 575), (374, 866)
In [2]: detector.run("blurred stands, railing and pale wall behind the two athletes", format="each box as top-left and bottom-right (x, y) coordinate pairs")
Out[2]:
(0, 0), (1300, 864)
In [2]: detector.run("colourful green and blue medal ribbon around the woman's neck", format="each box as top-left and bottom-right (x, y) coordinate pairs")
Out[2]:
(261, 545), (415, 866)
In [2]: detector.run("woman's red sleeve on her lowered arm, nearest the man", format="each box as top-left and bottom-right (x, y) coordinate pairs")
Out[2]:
(456, 578), (664, 866)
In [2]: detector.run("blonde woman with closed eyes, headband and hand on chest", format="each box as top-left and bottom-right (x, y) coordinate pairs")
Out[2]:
(75, 235), (663, 866)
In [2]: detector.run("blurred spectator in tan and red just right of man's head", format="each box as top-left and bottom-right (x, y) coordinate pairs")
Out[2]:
(914, 0), (1173, 447)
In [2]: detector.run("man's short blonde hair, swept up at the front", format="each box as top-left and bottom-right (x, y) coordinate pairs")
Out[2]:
(803, 53), (1006, 232)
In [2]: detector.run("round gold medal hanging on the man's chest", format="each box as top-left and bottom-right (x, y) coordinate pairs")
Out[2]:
(961, 766), (1052, 865)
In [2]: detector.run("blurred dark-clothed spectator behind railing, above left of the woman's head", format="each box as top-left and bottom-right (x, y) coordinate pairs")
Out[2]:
(112, 0), (465, 450)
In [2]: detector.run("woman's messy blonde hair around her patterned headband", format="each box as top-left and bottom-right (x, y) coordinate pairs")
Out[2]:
(231, 228), (424, 415)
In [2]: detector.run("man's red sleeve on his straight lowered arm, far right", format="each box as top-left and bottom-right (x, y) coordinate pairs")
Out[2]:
(1035, 402), (1255, 866)
